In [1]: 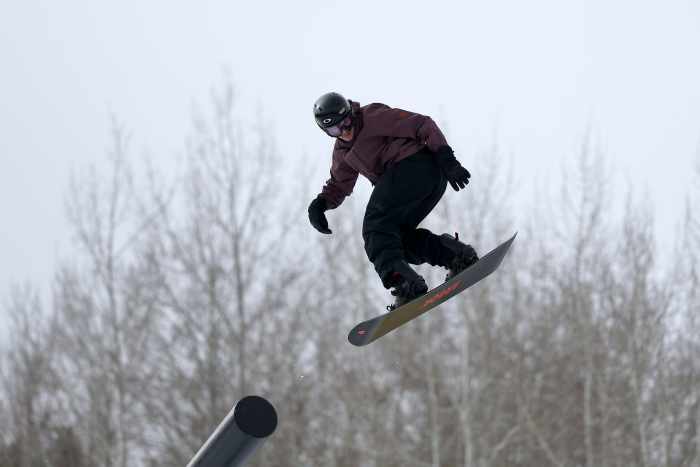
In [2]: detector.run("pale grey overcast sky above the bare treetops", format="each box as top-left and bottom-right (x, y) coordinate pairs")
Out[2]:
(0, 0), (700, 300)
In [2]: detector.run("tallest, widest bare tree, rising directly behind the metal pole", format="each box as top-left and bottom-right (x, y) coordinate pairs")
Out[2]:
(133, 78), (306, 464)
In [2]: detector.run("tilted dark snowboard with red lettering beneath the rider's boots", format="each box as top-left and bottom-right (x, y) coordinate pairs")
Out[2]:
(348, 232), (517, 347)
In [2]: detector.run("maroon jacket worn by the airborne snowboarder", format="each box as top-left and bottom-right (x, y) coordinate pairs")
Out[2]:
(321, 101), (447, 209)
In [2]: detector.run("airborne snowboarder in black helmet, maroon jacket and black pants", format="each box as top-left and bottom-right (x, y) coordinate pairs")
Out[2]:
(309, 92), (478, 310)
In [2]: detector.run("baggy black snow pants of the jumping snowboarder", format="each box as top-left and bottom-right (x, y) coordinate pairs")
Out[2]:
(362, 150), (453, 288)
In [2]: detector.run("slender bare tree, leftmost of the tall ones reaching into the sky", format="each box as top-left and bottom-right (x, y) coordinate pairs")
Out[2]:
(55, 120), (153, 467)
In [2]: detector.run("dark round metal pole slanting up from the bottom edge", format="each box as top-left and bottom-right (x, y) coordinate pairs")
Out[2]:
(187, 396), (277, 467)
